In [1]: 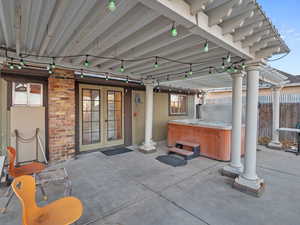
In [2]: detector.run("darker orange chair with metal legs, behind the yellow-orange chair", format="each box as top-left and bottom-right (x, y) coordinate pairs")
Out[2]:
(0, 147), (47, 213)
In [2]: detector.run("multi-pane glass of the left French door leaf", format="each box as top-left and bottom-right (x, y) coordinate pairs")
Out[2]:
(82, 89), (100, 145)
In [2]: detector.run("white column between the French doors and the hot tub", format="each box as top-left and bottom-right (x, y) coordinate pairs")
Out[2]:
(140, 81), (155, 153)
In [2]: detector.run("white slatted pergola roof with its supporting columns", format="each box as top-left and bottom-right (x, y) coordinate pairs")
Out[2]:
(0, 0), (289, 193)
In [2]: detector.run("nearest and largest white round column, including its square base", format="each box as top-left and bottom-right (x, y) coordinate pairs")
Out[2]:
(234, 62), (263, 193)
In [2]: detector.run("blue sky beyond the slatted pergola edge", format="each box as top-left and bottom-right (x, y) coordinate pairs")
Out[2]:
(257, 0), (300, 75)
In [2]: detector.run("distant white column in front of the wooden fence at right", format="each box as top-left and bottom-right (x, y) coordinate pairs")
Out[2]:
(269, 86), (282, 149)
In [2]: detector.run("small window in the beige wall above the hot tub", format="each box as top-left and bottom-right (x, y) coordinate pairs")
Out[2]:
(169, 94), (187, 116)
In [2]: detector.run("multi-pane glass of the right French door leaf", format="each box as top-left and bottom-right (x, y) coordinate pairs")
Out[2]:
(107, 91), (122, 141)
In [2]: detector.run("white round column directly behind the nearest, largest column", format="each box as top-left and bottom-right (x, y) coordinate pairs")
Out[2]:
(222, 72), (244, 177)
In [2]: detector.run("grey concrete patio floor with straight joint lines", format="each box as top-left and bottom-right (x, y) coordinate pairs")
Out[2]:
(0, 145), (300, 225)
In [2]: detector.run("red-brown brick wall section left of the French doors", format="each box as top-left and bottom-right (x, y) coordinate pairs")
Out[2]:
(48, 70), (75, 161)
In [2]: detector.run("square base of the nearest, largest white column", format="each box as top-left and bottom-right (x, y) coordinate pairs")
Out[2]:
(232, 175), (265, 197)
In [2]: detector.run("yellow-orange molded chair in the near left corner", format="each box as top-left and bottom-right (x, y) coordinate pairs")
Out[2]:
(12, 176), (83, 225)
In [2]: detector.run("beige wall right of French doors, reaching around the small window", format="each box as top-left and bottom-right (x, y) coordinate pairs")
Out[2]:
(132, 91), (194, 144)
